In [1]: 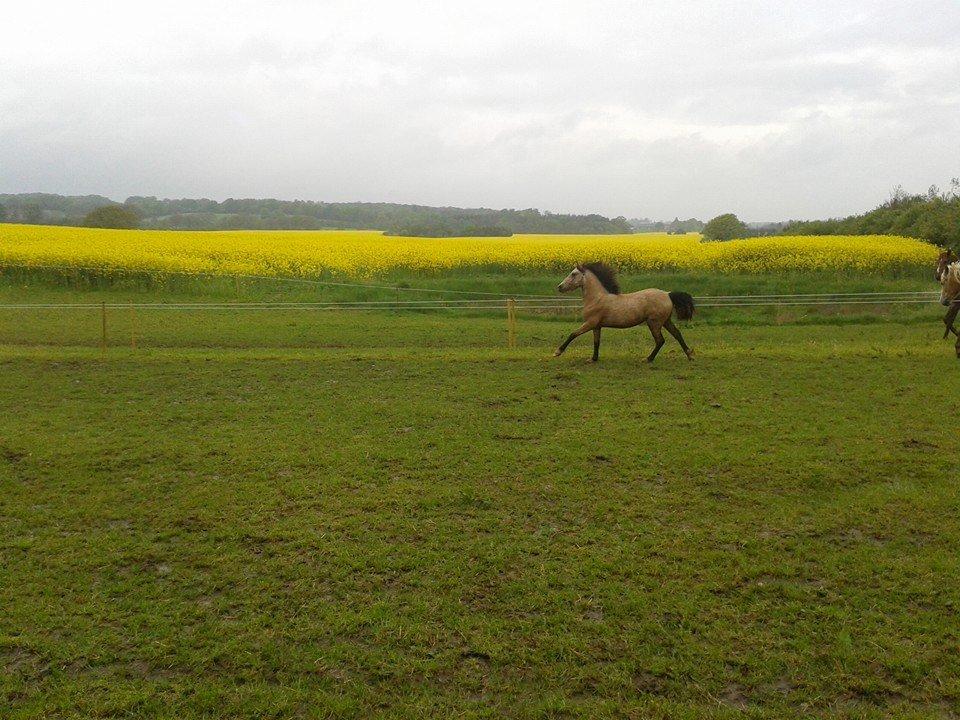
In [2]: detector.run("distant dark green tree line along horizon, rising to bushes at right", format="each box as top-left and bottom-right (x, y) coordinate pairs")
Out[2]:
(0, 186), (960, 251)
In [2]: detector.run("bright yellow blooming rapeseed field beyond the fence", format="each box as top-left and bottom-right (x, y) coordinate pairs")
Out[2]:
(0, 225), (936, 277)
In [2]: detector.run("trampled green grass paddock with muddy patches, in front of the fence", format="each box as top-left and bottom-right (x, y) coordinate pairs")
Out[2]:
(0, 266), (960, 718)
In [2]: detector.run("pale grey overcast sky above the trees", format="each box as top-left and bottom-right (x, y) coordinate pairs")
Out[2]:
(0, 0), (960, 220)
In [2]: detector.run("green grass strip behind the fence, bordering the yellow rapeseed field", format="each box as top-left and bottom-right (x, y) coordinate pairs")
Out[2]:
(0, 268), (942, 347)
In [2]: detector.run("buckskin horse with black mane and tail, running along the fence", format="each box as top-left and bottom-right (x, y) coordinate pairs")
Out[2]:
(554, 263), (693, 362)
